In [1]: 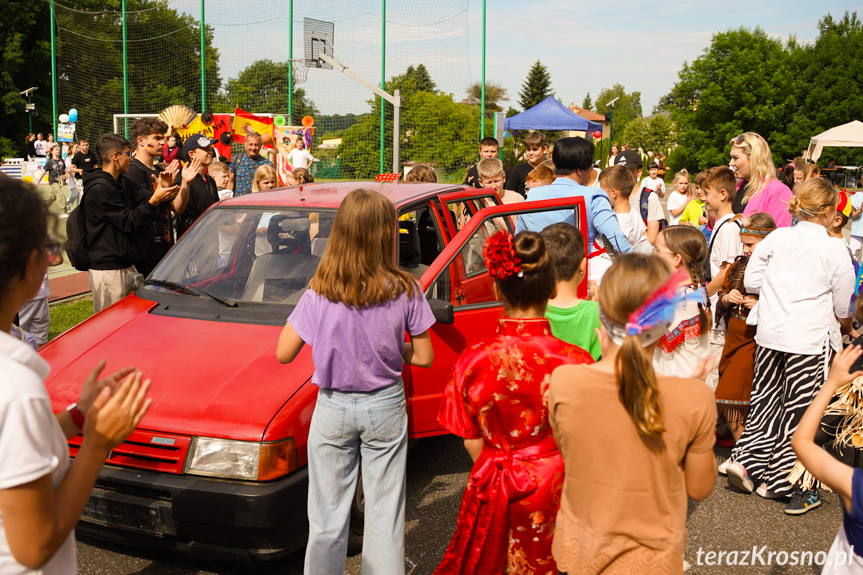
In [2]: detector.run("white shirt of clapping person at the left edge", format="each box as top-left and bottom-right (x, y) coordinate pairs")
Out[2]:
(0, 332), (76, 575)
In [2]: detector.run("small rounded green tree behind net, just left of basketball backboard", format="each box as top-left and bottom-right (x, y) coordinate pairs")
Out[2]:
(224, 60), (318, 122)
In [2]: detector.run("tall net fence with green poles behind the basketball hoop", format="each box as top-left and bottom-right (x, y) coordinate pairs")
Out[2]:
(55, 0), (491, 181)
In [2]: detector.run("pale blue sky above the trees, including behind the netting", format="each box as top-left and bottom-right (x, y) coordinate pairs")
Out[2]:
(202, 0), (855, 115)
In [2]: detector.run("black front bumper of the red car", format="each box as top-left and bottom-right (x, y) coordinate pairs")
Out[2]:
(77, 466), (309, 562)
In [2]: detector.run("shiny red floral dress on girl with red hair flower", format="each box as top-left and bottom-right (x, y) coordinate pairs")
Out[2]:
(435, 318), (593, 575)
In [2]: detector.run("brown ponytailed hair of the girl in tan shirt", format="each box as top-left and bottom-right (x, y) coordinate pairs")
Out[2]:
(599, 254), (671, 436)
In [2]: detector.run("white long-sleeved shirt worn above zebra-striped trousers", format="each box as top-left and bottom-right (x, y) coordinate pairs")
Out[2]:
(743, 222), (856, 355)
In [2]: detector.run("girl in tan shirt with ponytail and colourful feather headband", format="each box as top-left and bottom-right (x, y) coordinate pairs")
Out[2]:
(549, 254), (716, 575)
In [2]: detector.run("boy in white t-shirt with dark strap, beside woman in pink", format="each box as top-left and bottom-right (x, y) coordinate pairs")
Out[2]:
(701, 166), (743, 389)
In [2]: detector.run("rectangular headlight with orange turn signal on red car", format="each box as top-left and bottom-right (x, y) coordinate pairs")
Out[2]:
(185, 437), (299, 481)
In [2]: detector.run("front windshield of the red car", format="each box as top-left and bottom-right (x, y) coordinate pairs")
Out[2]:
(143, 207), (336, 307)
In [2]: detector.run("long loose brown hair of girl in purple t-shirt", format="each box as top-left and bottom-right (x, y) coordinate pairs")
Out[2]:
(309, 190), (419, 307)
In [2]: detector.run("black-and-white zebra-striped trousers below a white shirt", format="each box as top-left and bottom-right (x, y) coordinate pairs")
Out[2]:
(731, 346), (826, 496)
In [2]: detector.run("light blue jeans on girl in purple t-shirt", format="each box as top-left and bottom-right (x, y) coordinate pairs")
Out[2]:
(304, 379), (407, 575)
